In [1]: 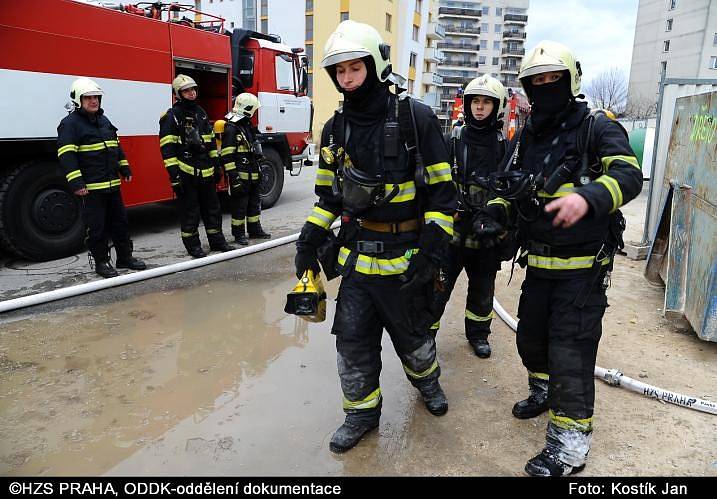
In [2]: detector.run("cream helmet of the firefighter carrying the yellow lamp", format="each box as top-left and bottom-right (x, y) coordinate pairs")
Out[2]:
(321, 19), (392, 91)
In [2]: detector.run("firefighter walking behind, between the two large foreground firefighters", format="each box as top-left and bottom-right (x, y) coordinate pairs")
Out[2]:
(433, 74), (507, 359)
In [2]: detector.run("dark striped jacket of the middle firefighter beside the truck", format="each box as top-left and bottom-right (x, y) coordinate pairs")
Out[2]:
(159, 101), (219, 185)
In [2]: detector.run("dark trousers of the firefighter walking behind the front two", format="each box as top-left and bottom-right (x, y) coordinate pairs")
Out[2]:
(433, 244), (500, 341)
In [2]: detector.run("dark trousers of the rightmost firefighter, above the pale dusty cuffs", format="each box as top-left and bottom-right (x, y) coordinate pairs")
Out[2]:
(516, 270), (607, 421)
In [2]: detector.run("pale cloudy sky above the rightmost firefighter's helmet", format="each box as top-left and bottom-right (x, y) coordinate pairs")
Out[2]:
(526, 0), (638, 85)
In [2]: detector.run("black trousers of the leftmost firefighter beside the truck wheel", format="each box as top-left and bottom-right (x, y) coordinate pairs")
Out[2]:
(80, 190), (131, 262)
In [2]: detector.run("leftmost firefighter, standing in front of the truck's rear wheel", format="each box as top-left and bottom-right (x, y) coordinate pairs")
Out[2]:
(57, 78), (147, 277)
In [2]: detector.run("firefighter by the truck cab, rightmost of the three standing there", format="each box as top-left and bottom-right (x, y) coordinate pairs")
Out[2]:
(221, 92), (271, 246)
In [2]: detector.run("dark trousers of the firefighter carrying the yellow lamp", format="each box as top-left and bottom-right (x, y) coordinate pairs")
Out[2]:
(332, 272), (440, 417)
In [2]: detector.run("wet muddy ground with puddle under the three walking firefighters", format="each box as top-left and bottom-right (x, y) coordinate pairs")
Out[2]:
(0, 246), (717, 476)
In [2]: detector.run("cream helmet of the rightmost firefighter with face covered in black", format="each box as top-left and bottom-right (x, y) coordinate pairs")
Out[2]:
(518, 40), (583, 97)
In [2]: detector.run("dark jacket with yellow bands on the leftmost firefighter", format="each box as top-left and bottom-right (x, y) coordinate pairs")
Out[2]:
(57, 108), (132, 192)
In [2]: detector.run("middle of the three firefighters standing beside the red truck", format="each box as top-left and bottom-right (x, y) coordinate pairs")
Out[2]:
(159, 74), (234, 258)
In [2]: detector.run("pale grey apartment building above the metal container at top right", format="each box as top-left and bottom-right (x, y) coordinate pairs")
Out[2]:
(628, 0), (717, 108)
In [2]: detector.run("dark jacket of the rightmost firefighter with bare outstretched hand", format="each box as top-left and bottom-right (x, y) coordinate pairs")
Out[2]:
(498, 102), (642, 278)
